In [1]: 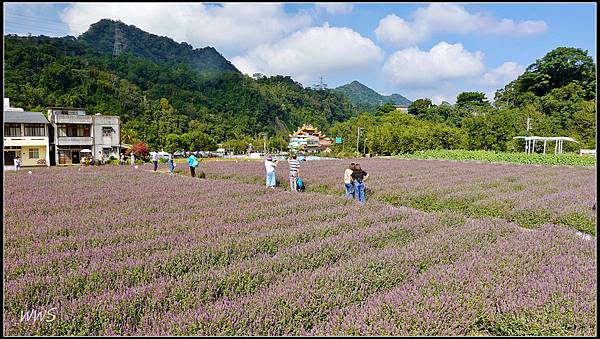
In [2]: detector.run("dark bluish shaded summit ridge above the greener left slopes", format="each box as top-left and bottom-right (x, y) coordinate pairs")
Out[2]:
(78, 19), (239, 72)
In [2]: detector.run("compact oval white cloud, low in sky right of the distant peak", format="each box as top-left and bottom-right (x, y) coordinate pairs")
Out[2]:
(383, 41), (485, 88)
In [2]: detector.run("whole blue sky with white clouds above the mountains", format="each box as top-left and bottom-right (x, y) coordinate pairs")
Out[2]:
(4, 2), (597, 103)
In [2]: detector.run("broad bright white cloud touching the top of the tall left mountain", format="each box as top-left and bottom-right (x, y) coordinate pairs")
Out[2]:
(61, 3), (312, 53)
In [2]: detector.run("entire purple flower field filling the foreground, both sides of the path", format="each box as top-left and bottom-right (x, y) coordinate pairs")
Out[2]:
(3, 163), (597, 336)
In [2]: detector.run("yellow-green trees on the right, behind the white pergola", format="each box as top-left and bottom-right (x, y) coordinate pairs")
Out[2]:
(330, 47), (596, 155)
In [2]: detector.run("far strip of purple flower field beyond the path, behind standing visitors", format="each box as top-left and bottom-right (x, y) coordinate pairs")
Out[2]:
(184, 159), (597, 235)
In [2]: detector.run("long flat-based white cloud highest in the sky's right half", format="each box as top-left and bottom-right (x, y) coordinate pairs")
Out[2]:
(375, 3), (548, 47)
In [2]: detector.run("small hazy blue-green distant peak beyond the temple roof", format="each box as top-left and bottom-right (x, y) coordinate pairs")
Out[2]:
(334, 81), (411, 110)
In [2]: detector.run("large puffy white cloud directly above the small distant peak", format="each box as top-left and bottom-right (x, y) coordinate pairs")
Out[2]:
(231, 24), (384, 84)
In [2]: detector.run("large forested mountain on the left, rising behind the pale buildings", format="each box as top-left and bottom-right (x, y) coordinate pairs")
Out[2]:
(4, 20), (358, 150)
